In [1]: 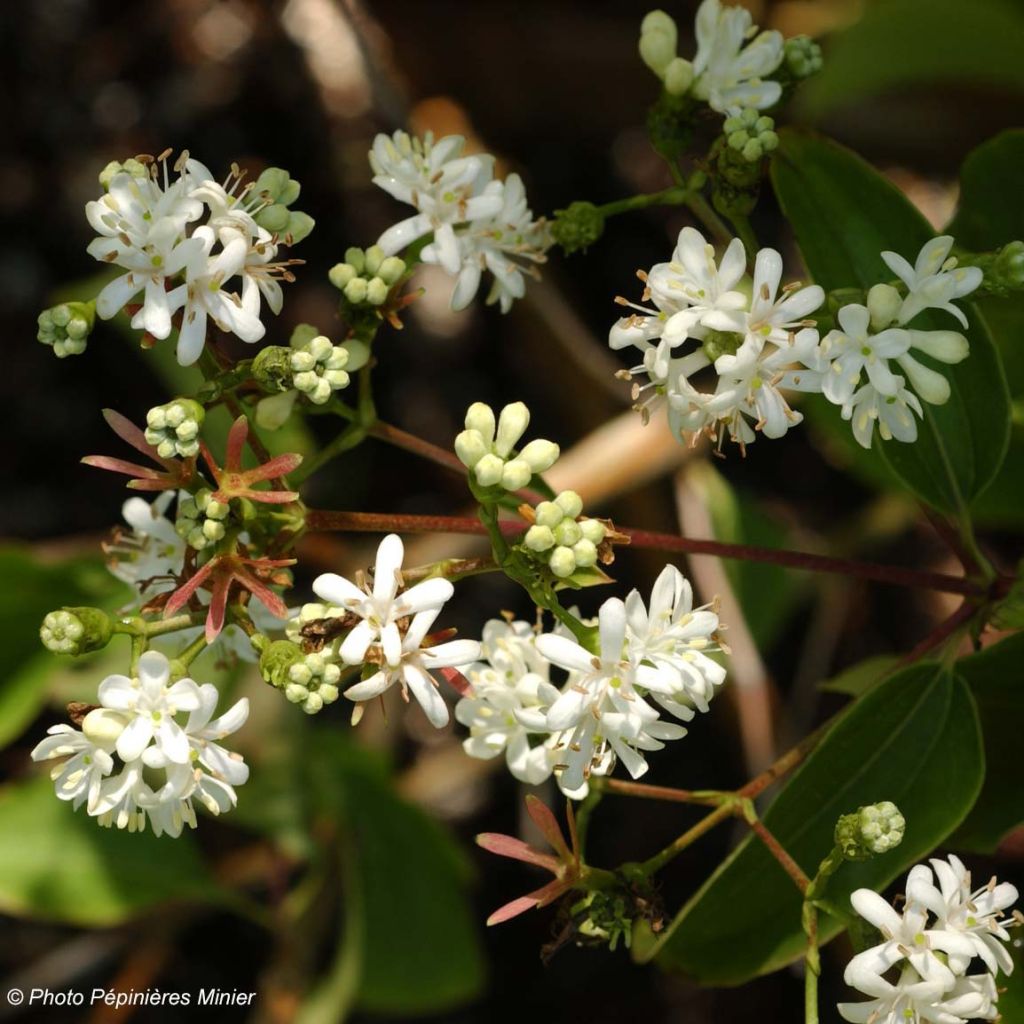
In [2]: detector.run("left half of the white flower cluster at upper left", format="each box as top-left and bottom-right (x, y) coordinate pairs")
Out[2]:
(85, 154), (210, 338)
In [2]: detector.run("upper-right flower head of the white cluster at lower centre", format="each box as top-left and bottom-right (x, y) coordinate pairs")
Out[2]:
(625, 565), (725, 721)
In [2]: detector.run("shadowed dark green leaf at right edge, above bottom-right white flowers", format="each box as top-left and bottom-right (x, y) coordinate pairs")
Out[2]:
(949, 634), (1024, 853)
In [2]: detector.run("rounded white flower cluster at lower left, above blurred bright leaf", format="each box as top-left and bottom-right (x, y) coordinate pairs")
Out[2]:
(32, 650), (249, 836)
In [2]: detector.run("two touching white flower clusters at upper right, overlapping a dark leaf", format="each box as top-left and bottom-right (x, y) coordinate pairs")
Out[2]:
(608, 227), (981, 456)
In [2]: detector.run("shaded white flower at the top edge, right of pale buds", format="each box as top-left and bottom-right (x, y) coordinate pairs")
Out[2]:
(692, 0), (784, 114)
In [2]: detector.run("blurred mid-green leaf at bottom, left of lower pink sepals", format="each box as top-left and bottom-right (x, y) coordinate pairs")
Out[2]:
(303, 731), (483, 1020)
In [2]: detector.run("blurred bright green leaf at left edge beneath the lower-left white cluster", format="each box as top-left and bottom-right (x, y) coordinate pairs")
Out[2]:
(0, 777), (231, 926)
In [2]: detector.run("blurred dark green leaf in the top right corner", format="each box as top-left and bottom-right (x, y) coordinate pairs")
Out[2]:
(798, 0), (1024, 118)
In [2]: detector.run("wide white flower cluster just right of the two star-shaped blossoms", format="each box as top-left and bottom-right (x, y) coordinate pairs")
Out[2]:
(456, 565), (725, 799)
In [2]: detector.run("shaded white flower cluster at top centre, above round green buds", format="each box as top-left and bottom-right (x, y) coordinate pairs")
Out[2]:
(370, 131), (551, 312)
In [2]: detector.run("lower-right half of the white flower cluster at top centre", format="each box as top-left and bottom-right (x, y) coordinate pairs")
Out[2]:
(421, 174), (552, 313)
